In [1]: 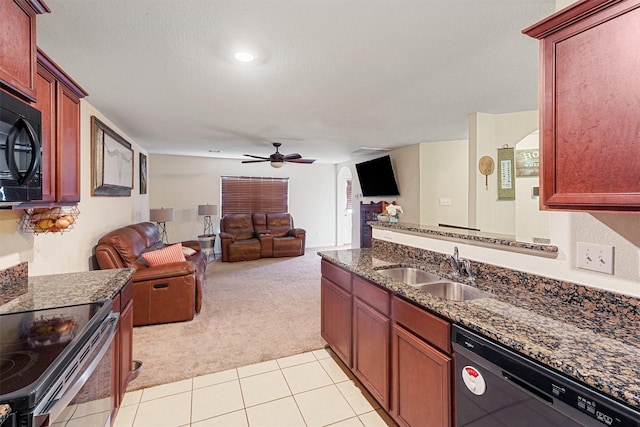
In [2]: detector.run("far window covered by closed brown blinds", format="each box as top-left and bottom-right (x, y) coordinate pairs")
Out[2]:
(220, 176), (289, 216)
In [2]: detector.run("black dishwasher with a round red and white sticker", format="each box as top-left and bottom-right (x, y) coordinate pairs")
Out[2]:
(452, 325), (640, 427)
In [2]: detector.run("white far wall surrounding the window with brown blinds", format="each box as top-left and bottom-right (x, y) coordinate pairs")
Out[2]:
(149, 155), (337, 248)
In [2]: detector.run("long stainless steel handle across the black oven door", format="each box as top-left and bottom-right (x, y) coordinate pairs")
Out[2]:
(33, 313), (120, 426)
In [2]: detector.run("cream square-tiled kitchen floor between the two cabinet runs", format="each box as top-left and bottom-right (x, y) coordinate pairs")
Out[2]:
(114, 349), (395, 427)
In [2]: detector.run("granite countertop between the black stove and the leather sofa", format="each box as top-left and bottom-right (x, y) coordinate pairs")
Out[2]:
(0, 268), (135, 314)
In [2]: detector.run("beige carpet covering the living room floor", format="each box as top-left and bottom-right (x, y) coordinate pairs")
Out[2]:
(128, 248), (335, 390)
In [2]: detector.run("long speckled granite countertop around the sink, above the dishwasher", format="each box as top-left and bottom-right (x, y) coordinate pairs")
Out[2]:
(318, 249), (640, 410)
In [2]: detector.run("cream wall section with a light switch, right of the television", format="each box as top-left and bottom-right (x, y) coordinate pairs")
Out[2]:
(418, 139), (469, 226)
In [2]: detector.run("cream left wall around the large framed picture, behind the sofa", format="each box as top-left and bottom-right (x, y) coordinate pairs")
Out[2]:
(0, 100), (149, 276)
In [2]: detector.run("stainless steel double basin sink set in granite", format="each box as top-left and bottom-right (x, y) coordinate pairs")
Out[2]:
(376, 267), (492, 301)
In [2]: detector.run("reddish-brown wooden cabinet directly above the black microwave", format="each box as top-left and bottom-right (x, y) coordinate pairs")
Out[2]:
(0, 0), (50, 101)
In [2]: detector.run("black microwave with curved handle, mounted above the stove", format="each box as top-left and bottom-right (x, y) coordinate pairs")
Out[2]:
(0, 91), (42, 206)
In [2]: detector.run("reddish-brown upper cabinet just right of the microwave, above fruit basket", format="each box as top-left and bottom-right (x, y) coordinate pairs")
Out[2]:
(34, 50), (87, 203)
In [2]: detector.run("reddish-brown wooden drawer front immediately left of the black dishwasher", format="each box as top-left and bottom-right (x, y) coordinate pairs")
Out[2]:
(391, 296), (451, 354)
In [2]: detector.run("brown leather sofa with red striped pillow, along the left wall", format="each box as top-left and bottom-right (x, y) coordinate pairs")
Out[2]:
(95, 222), (207, 326)
